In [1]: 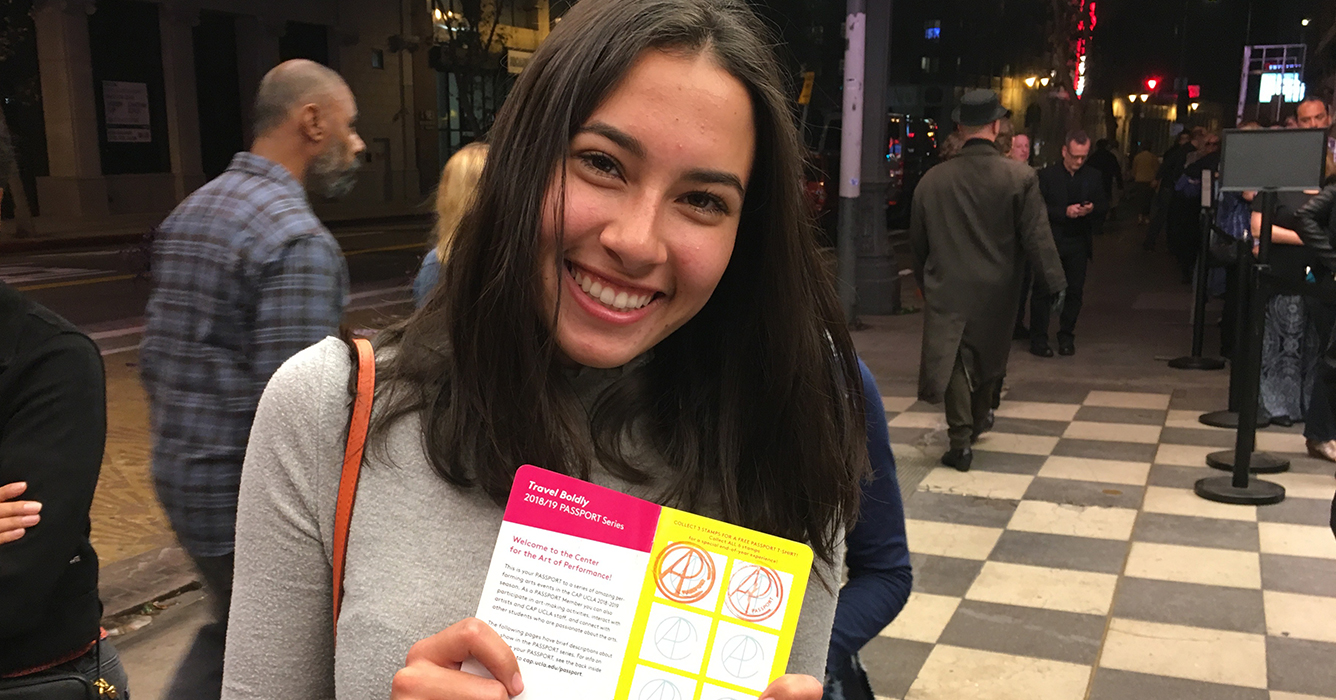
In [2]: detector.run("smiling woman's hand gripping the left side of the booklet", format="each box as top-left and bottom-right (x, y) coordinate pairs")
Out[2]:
(390, 617), (523, 700)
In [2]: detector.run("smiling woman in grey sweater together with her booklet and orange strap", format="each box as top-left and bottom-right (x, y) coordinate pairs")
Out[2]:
(223, 0), (868, 700)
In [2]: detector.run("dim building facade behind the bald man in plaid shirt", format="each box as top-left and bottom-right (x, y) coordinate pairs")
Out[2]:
(16, 0), (556, 232)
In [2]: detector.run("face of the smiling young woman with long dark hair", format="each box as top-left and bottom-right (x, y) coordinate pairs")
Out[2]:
(538, 51), (756, 367)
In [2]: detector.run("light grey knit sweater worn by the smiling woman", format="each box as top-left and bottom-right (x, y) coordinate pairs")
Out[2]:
(223, 338), (843, 700)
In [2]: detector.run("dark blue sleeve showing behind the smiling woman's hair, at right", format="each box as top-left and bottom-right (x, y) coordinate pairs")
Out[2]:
(827, 359), (914, 672)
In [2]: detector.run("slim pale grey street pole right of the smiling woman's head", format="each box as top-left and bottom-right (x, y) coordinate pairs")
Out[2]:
(835, 0), (867, 323)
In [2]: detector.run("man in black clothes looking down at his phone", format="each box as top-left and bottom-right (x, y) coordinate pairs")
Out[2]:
(1030, 131), (1109, 357)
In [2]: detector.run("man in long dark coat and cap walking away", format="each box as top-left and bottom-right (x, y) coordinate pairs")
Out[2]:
(910, 90), (1066, 472)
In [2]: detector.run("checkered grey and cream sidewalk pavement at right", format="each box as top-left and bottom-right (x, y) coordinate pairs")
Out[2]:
(855, 220), (1336, 700)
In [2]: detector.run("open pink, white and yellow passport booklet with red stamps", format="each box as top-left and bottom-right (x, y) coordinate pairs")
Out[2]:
(464, 465), (812, 700)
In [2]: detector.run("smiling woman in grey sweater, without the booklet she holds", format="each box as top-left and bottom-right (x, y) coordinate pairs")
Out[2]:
(224, 0), (868, 700)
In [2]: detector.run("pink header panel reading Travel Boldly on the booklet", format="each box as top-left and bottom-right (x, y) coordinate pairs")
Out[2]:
(505, 465), (663, 552)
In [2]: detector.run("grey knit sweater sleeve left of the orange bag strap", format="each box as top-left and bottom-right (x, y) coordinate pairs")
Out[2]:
(222, 338), (351, 700)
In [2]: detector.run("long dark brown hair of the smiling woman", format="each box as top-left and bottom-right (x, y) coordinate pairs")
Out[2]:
(373, 0), (867, 562)
